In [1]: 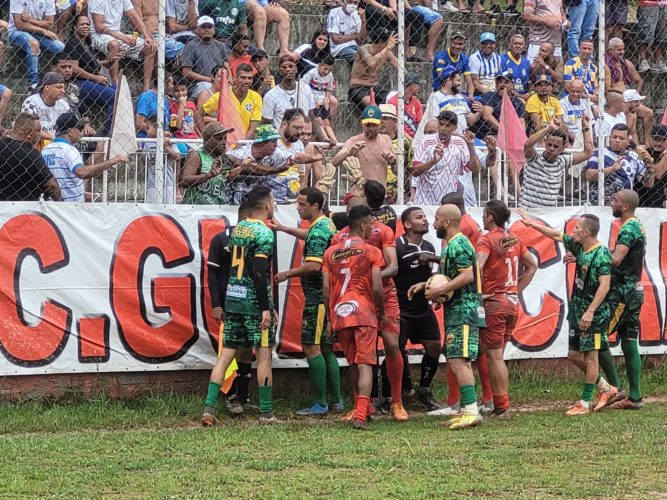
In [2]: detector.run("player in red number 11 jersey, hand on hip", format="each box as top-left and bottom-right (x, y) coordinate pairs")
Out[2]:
(477, 200), (537, 417)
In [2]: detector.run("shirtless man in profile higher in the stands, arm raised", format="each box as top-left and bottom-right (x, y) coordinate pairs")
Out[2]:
(347, 34), (398, 109)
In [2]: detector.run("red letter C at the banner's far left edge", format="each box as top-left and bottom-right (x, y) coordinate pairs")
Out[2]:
(0, 213), (72, 367)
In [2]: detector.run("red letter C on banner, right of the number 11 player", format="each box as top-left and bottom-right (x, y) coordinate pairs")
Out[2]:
(510, 222), (565, 352)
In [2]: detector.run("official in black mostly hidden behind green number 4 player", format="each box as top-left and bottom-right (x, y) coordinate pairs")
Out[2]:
(206, 202), (252, 415)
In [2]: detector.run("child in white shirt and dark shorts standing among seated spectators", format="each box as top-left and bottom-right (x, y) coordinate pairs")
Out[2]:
(301, 55), (338, 143)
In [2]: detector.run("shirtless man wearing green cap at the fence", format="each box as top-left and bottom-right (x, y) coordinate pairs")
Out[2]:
(331, 106), (396, 188)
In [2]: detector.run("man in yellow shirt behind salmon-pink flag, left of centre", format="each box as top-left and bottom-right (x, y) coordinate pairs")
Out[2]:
(195, 64), (262, 139)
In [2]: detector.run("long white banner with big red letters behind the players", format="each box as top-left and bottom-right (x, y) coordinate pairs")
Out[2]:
(0, 203), (667, 375)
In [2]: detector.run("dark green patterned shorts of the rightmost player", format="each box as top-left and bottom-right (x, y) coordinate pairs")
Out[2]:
(607, 283), (644, 339)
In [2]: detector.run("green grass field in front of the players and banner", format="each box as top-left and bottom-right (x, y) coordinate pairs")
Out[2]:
(0, 366), (667, 498)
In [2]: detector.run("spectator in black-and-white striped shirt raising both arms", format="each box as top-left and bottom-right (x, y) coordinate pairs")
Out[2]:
(519, 115), (594, 208)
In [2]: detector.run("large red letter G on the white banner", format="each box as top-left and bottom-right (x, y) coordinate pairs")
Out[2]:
(110, 215), (198, 363)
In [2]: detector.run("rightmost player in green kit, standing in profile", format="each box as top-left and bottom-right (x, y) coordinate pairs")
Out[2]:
(595, 189), (646, 410)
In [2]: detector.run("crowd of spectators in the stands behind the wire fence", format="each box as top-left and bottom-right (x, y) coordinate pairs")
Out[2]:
(0, 0), (667, 207)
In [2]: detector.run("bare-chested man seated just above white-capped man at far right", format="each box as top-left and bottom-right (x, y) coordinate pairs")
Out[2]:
(604, 38), (653, 141)
